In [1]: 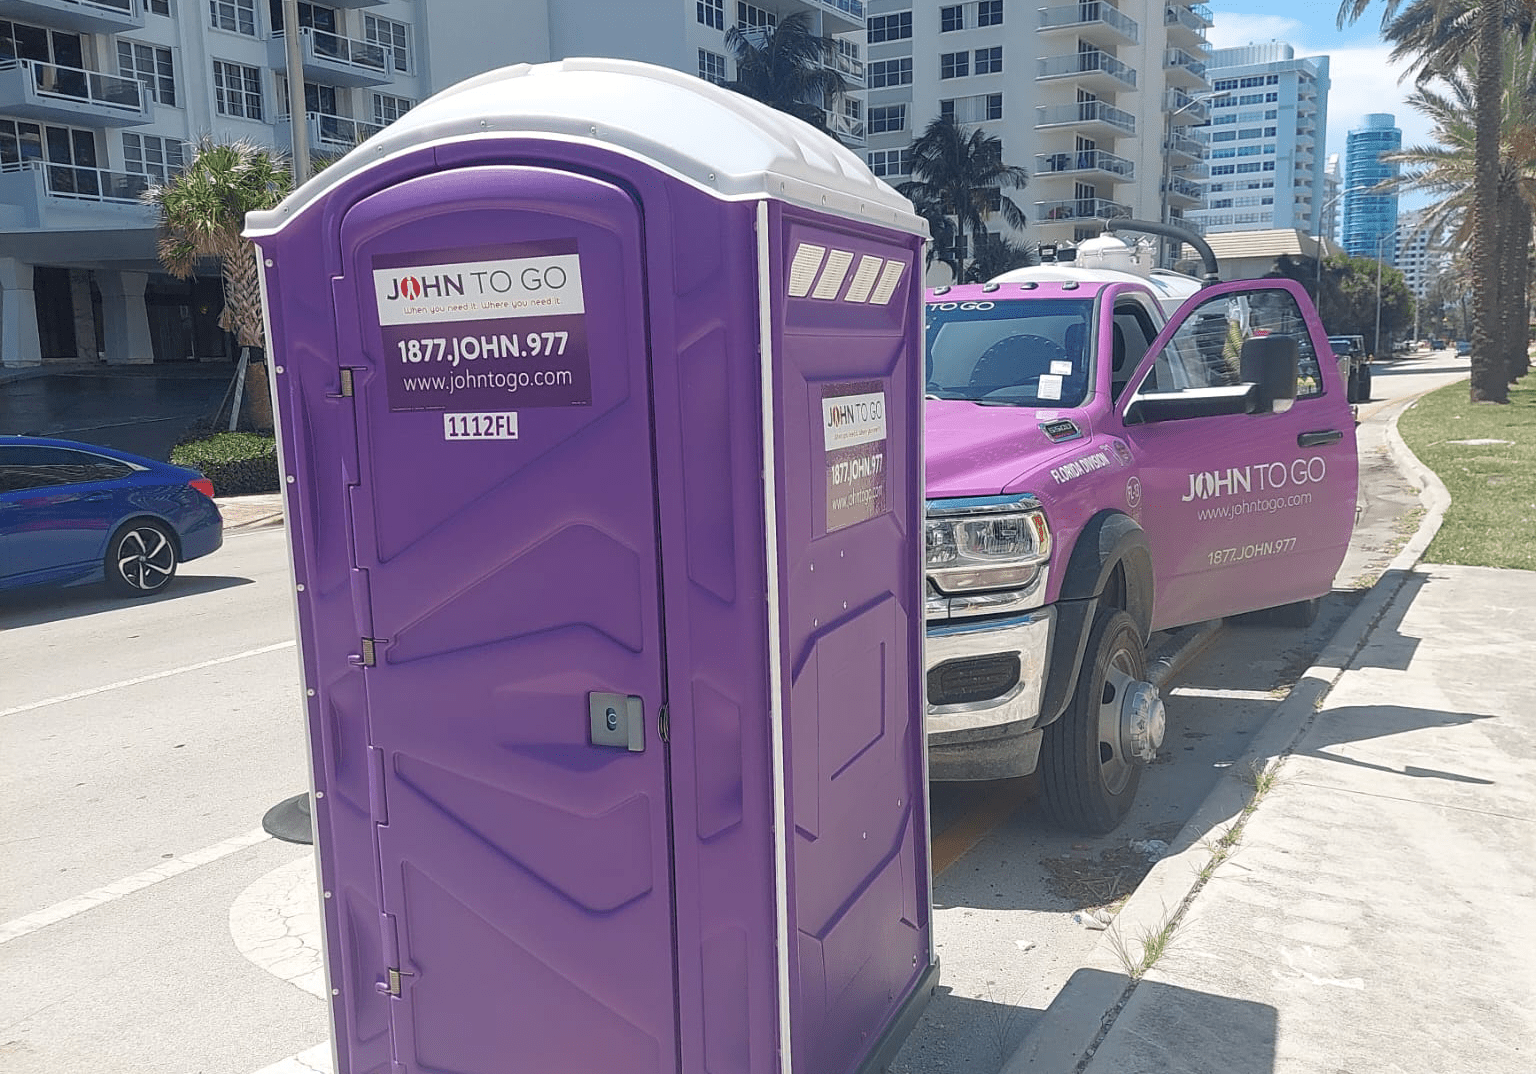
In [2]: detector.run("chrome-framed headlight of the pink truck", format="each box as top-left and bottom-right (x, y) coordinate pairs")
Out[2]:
(923, 496), (1051, 593)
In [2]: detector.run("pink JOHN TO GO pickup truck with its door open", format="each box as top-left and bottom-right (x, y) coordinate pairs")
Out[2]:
(925, 221), (1358, 833)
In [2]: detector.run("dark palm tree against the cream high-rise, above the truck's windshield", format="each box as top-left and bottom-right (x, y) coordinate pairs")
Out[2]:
(895, 115), (1029, 281)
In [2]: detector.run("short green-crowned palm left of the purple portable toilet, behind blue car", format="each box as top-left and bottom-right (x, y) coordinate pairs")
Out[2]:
(143, 135), (293, 429)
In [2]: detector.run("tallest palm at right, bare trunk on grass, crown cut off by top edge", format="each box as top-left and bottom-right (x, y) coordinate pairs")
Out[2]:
(1338, 0), (1536, 403)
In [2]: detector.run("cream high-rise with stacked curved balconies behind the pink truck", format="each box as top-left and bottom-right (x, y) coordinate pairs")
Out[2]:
(865, 0), (1210, 275)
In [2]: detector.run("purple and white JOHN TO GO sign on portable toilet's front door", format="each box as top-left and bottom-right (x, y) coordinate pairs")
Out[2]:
(373, 240), (591, 412)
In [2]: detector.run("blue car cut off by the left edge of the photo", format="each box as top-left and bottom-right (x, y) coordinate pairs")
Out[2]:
(0, 436), (224, 596)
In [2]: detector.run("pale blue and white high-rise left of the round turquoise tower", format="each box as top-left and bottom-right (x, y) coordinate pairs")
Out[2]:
(1190, 41), (1329, 235)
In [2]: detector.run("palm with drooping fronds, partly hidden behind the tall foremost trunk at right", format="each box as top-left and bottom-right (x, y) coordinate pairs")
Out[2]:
(1385, 37), (1536, 381)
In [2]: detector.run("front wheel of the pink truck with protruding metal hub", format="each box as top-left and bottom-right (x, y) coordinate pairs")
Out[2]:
(1040, 608), (1164, 834)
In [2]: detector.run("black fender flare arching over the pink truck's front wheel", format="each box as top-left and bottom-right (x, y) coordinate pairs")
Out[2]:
(1040, 510), (1154, 727)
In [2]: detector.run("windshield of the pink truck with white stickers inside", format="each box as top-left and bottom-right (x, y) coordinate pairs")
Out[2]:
(926, 298), (1094, 407)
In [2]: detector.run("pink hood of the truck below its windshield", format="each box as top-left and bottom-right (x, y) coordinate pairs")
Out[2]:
(923, 399), (1094, 499)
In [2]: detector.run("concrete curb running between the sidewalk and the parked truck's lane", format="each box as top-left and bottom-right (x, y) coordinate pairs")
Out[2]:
(1000, 392), (1450, 1074)
